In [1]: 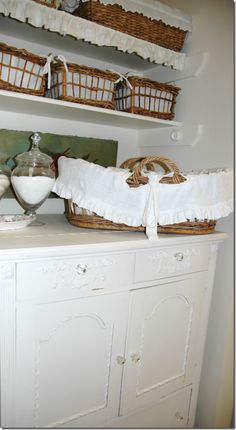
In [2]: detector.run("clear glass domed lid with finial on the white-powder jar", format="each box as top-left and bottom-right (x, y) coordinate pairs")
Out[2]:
(16, 133), (53, 165)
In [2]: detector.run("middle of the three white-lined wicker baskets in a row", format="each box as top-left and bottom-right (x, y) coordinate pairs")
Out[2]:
(48, 63), (118, 109)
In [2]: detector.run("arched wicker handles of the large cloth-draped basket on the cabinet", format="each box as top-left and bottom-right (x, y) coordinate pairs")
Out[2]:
(121, 156), (186, 186)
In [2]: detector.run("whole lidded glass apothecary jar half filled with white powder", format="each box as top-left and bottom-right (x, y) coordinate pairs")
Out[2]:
(11, 133), (55, 220)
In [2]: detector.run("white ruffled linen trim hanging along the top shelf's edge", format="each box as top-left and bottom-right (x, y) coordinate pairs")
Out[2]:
(0, 0), (186, 70)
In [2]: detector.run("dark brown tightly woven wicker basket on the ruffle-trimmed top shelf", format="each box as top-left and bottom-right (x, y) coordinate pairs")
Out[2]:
(73, 0), (187, 52)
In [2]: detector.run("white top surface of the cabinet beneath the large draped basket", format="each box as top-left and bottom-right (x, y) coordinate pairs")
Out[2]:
(0, 215), (226, 260)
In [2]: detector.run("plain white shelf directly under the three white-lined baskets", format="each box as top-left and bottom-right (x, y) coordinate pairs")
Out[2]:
(0, 90), (182, 130)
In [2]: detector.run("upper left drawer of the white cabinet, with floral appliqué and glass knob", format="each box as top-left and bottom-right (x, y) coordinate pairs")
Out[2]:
(17, 254), (134, 301)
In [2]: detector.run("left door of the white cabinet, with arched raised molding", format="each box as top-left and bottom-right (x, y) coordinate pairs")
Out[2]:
(15, 293), (128, 427)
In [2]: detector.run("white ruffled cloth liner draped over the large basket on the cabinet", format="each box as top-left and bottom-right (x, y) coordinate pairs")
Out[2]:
(53, 157), (233, 240)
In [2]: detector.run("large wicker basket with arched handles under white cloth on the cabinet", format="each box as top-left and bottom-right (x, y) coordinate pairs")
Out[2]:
(65, 156), (216, 234)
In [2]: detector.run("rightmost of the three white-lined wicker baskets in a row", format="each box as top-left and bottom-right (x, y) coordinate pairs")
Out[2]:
(116, 76), (180, 120)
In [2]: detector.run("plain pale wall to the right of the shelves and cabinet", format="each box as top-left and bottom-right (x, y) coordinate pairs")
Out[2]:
(139, 0), (234, 428)
